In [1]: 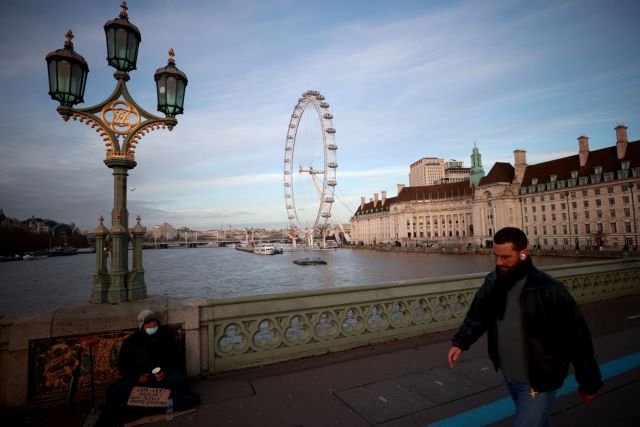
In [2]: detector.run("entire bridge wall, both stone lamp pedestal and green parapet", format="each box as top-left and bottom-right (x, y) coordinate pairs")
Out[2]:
(0, 258), (640, 407)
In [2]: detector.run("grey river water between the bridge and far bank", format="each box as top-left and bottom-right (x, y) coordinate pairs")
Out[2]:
(0, 247), (588, 316)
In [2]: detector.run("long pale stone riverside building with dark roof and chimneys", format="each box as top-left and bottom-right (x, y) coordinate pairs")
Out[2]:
(351, 125), (640, 249)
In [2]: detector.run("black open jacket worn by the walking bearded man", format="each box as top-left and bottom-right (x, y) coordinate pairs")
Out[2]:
(452, 266), (602, 395)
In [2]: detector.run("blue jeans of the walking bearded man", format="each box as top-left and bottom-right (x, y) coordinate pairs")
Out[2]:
(502, 373), (556, 427)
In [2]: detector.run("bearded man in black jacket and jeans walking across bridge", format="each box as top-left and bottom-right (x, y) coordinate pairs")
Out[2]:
(448, 227), (602, 427)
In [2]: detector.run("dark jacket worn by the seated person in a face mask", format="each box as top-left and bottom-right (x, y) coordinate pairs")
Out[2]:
(118, 326), (179, 382)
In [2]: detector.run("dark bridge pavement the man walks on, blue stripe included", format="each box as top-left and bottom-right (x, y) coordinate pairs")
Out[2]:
(4, 295), (640, 427)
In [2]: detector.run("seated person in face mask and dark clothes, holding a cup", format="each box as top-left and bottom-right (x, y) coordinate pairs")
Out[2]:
(97, 310), (200, 426)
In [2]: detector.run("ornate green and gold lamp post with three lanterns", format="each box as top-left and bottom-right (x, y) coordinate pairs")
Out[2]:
(45, 1), (187, 303)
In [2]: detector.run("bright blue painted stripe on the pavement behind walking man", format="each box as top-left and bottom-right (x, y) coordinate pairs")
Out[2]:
(427, 353), (640, 427)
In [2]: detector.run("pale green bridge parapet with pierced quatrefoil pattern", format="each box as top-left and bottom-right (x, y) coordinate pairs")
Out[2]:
(200, 259), (640, 374)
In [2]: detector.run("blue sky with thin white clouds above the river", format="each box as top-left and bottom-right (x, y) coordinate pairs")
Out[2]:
(0, 0), (640, 234)
